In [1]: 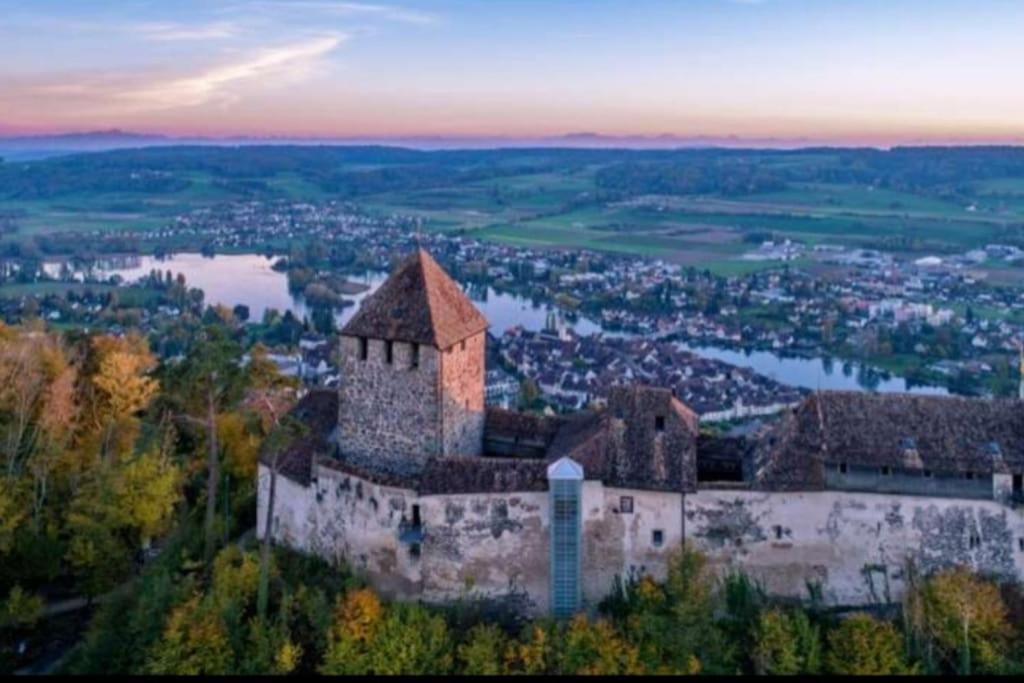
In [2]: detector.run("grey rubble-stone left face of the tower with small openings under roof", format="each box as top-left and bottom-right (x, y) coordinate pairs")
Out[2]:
(338, 337), (442, 467)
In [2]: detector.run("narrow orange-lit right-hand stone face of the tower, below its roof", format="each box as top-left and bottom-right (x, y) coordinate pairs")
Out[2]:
(440, 332), (486, 456)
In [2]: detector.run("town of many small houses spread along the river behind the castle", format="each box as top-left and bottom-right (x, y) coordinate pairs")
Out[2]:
(0, 193), (1024, 419)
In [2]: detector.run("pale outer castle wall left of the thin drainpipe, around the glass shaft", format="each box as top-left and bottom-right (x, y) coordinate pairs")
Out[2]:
(258, 458), (682, 614)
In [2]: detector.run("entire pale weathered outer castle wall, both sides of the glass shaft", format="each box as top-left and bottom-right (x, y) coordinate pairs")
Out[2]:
(258, 465), (1024, 614)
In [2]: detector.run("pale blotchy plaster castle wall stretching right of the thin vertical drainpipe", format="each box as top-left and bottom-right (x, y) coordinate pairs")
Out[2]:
(685, 490), (1024, 605)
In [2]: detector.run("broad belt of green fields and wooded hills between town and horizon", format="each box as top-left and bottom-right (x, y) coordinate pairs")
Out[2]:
(6, 147), (1024, 278)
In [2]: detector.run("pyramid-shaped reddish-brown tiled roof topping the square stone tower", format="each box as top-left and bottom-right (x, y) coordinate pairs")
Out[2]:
(341, 249), (488, 349)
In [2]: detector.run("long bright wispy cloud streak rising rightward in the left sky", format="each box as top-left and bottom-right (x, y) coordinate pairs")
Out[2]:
(7, 34), (346, 115)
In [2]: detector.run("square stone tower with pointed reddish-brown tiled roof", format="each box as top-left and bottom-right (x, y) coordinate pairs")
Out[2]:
(338, 249), (487, 472)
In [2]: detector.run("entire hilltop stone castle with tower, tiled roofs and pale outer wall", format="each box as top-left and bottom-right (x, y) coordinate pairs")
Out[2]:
(257, 250), (1024, 615)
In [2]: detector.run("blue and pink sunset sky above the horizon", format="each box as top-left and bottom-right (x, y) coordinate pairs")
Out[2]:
(0, 0), (1024, 145)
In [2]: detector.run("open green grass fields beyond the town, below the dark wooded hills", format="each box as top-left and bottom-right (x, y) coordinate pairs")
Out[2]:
(6, 158), (1024, 280)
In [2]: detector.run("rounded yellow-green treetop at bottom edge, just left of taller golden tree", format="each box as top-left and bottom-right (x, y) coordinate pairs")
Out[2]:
(825, 612), (912, 676)
